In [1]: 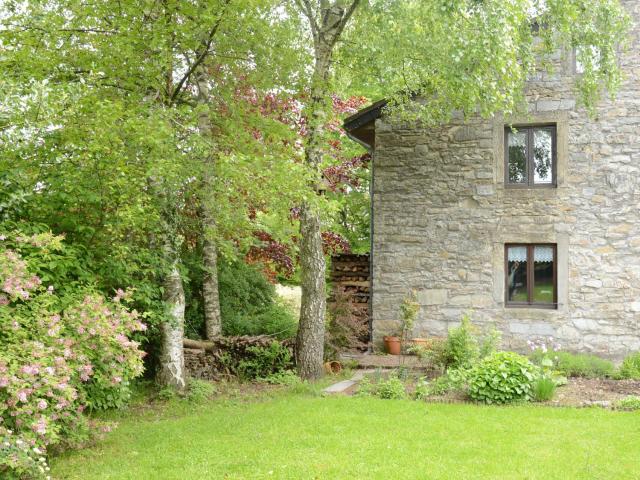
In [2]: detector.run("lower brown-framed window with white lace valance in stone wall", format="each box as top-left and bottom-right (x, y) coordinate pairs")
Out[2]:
(505, 243), (558, 308)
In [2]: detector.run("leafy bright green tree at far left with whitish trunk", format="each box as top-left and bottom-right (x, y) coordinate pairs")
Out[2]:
(0, 0), (308, 387)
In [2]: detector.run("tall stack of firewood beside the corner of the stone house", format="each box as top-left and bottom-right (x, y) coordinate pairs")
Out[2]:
(328, 254), (371, 350)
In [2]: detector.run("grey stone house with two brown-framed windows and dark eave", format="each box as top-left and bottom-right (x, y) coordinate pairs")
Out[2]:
(345, 0), (640, 358)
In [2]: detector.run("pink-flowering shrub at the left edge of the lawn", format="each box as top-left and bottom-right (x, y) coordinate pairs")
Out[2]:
(0, 234), (145, 478)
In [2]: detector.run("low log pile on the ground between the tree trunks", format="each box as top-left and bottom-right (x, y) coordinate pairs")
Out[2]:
(183, 335), (293, 380)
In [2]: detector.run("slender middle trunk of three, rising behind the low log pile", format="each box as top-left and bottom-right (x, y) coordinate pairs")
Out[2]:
(196, 69), (222, 340)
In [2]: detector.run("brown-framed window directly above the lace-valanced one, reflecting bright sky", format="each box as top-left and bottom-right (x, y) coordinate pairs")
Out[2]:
(504, 125), (556, 187)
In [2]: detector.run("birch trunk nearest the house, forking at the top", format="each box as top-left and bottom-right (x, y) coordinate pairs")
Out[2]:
(296, 0), (359, 379)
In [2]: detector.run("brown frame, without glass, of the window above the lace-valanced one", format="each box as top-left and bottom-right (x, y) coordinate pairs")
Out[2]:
(504, 123), (558, 188)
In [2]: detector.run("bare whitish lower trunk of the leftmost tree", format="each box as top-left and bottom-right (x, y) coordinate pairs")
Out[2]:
(158, 255), (186, 390)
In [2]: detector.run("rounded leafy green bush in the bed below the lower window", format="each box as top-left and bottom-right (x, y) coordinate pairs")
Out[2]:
(468, 352), (539, 403)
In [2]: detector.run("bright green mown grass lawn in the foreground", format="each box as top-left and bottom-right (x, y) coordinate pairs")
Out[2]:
(52, 393), (640, 480)
